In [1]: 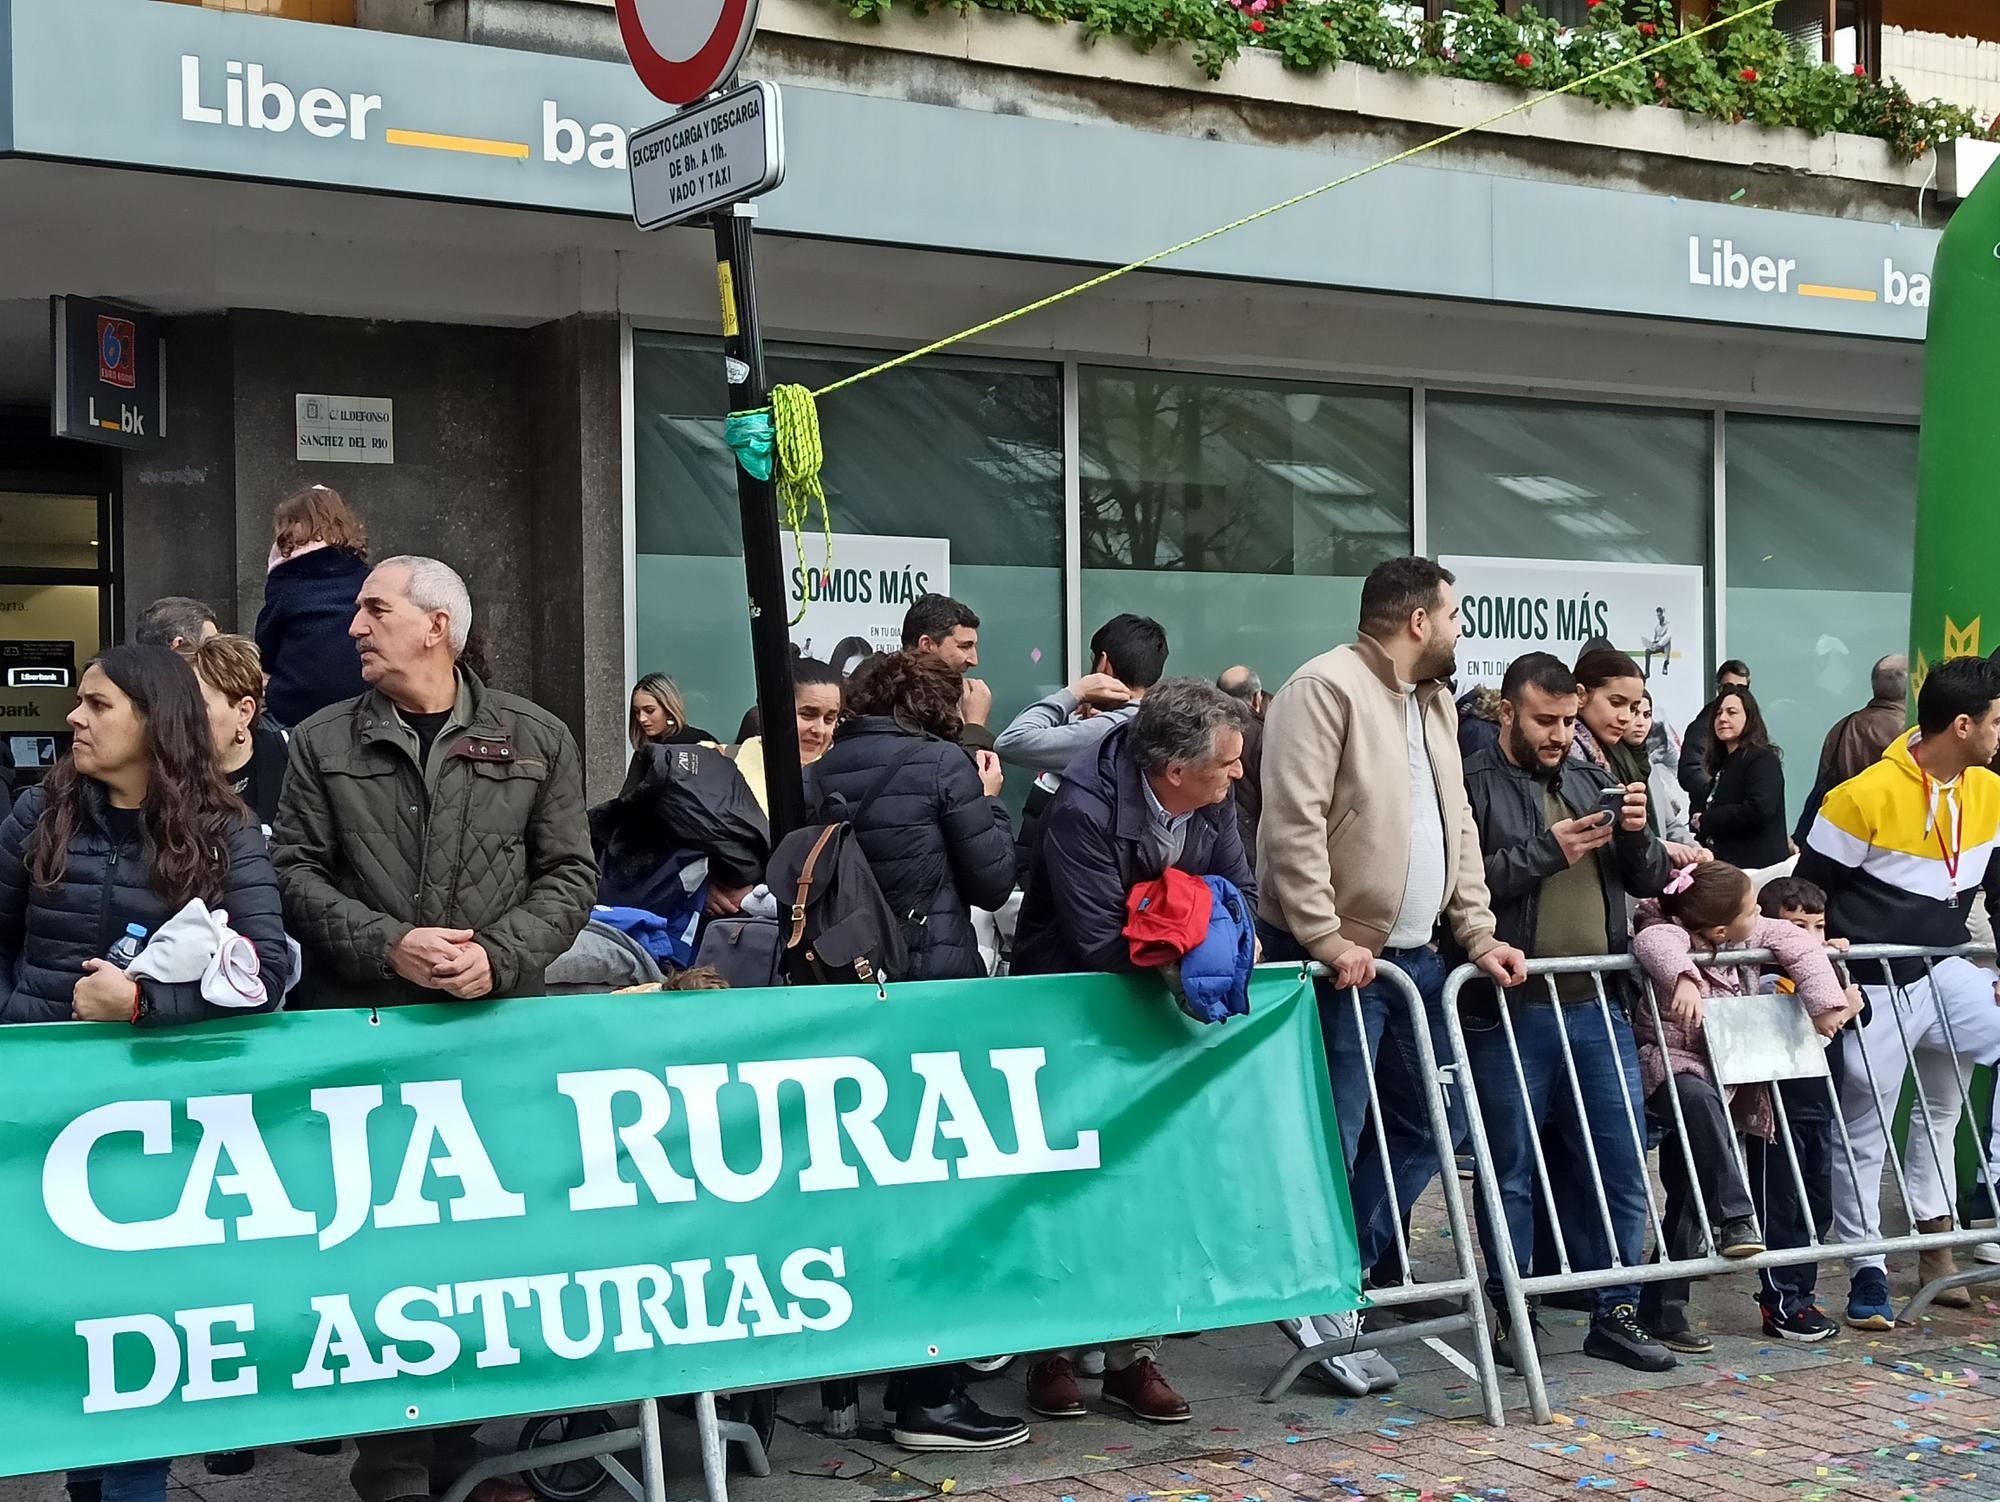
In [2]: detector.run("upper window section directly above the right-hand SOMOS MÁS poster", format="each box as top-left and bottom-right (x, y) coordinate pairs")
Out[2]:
(1424, 392), (1714, 564)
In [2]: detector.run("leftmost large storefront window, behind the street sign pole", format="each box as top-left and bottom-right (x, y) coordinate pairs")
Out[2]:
(632, 332), (1062, 756)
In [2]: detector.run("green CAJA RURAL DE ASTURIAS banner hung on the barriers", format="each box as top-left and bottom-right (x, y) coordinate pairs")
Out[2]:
(0, 970), (1358, 1474)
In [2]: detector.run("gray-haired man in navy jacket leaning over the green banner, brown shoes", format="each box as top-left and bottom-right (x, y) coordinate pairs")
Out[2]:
(1014, 678), (1256, 1424)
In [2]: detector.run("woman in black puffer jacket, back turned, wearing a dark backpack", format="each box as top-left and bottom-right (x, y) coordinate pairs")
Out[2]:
(812, 652), (1014, 980)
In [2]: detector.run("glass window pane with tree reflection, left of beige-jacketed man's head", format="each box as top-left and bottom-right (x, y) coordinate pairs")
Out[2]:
(1074, 368), (1412, 688)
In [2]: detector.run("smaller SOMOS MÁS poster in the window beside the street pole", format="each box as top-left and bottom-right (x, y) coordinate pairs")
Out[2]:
(784, 532), (952, 670)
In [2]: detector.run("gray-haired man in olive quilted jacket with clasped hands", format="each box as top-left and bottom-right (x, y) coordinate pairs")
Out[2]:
(272, 556), (598, 1502)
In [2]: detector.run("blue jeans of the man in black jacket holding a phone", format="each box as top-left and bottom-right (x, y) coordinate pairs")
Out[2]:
(1464, 992), (1648, 1314)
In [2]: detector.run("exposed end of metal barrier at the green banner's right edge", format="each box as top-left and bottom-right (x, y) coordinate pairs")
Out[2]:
(1260, 962), (1504, 1426)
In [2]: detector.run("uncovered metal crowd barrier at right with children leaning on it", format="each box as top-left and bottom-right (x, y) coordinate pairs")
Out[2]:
(1444, 944), (2000, 1424)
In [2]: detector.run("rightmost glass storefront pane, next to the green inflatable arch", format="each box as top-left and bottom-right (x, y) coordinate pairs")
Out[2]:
(1724, 416), (1916, 818)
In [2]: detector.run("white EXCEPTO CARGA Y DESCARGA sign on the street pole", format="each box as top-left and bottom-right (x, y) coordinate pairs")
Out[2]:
(626, 82), (784, 230)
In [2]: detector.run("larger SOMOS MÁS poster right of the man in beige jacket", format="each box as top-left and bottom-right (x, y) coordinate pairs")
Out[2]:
(1438, 556), (1708, 734)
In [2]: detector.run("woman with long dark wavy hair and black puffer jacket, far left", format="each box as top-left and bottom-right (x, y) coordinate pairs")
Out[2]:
(0, 646), (290, 1026)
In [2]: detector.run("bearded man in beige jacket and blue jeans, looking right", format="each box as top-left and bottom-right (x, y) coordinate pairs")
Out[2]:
(1258, 558), (1526, 1396)
